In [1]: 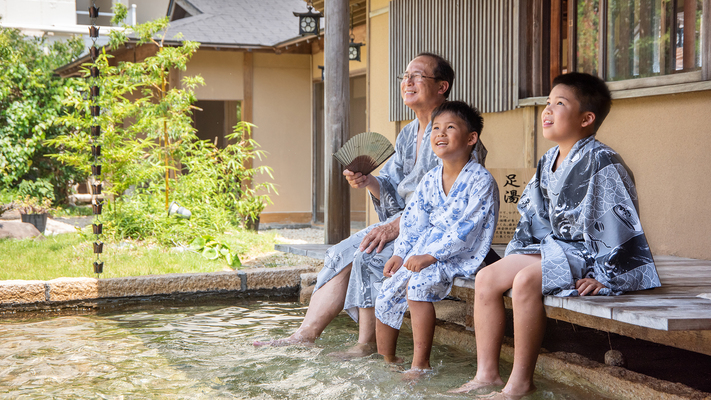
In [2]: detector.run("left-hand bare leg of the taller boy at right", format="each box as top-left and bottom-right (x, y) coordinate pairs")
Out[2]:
(451, 255), (541, 393)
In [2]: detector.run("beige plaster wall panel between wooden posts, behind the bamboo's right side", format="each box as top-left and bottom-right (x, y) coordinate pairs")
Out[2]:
(253, 53), (312, 214)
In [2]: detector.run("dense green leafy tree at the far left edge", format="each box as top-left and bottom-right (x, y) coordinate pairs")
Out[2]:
(0, 23), (83, 201)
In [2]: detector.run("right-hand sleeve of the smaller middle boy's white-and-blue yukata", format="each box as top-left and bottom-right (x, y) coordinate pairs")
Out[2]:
(423, 168), (499, 261)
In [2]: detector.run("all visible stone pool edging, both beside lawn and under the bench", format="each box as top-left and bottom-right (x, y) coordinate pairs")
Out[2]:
(0, 266), (711, 400)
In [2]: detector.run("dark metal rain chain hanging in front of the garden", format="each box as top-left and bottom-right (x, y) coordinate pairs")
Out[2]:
(88, 0), (104, 278)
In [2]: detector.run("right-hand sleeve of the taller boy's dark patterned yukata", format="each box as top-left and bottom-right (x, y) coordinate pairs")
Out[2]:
(583, 152), (661, 295)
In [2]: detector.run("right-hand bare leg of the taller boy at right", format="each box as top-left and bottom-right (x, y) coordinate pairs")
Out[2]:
(503, 261), (546, 396)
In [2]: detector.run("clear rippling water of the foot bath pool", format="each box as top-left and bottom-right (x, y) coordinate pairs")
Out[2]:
(0, 301), (612, 400)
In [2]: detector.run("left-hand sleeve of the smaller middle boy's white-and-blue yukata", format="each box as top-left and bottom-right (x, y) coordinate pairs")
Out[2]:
(393, 173), (433, 260)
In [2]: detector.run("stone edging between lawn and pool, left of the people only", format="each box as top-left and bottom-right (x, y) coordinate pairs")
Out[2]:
(0, 266), (313, 310)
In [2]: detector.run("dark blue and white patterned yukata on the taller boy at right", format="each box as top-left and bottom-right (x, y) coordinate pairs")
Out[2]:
(506, 135), (661, 297)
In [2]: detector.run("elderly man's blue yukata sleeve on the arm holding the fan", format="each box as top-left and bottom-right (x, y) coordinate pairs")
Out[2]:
(368, 134), (409, 222)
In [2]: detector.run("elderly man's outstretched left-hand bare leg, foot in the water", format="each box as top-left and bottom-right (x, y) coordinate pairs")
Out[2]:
(254, 264), (351, 346)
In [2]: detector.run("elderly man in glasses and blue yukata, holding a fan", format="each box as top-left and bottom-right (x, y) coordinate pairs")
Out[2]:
(255, 53), (490, 357)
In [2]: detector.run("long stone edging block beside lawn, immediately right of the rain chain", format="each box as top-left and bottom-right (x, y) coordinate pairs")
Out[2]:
(97, 271), (242, 298)
